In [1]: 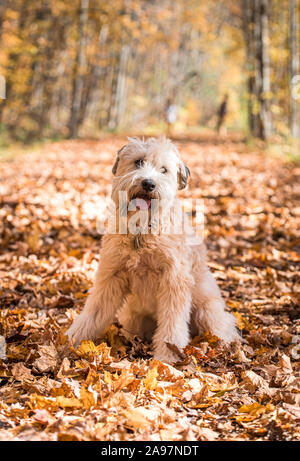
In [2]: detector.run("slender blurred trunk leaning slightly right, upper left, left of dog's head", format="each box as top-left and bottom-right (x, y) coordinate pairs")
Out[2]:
(68, 0), (89, 138)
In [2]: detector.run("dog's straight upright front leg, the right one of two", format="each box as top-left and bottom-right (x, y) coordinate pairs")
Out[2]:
(153, 280), (191, 363)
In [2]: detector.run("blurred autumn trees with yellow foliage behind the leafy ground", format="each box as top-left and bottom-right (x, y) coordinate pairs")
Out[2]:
(0, 0), (300, 144)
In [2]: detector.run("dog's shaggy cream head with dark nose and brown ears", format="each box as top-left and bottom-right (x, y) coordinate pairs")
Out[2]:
(112, 138), (190, 208)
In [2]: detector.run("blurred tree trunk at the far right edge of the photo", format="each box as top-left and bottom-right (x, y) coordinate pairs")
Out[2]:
(289, 0), (300, 139)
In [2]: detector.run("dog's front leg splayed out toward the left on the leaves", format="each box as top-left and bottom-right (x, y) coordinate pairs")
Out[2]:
(67, 264), (127, 346)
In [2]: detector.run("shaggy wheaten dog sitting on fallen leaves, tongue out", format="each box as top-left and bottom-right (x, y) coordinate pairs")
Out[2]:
(67, 138), (240, 363)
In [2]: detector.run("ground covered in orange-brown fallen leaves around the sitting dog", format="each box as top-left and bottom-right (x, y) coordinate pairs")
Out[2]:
(0, 137), (300, 441)
